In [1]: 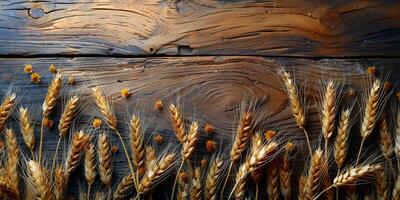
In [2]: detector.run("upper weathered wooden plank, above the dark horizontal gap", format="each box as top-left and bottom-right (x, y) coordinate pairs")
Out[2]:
(0, 0), (400, 57)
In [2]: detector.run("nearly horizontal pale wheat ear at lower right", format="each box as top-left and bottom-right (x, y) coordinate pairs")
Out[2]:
(333, 164), (382, 187)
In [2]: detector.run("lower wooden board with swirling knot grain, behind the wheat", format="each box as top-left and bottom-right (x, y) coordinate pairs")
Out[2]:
(0, 56), (400, 197)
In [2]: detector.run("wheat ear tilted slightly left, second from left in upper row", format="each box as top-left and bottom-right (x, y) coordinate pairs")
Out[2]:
(18, 107), (35, 152)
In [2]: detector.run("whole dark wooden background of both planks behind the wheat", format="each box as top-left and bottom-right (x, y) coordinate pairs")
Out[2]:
(0, 0), (400, 198)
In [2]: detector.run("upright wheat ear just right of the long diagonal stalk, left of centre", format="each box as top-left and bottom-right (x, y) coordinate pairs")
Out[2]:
(130, 115), (145, 175)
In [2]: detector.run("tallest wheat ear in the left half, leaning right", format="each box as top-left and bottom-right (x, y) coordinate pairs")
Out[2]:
(42, 74), (62, 118)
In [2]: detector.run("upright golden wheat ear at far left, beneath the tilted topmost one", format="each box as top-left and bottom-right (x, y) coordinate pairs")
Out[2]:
(5, 129), (20, 196)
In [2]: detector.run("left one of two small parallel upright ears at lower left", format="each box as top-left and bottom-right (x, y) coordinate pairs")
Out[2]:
(83, 143), (96, 186)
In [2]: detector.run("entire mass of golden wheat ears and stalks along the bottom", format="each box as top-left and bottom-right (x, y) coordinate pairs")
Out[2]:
(0, 64), (400, 200)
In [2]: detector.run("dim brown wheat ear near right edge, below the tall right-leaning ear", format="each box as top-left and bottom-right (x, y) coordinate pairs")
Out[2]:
(379, 114), (393, 161)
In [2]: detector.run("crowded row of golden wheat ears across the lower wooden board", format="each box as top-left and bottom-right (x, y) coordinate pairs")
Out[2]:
(0, 66), (400, 200)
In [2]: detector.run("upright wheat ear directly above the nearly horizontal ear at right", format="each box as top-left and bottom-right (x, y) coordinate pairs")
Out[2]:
(333, 109), (351, 169)
